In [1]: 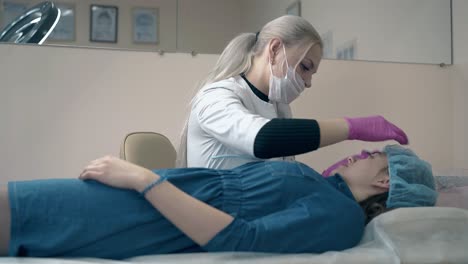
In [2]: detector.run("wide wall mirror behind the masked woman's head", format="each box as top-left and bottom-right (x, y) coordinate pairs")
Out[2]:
(0, 0), (452, 64)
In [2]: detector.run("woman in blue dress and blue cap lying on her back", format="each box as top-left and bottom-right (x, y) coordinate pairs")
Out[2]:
(0, 145), (437, 259)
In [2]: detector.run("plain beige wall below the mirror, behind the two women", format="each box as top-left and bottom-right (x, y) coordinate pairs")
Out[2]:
(0, 44), (453, 182)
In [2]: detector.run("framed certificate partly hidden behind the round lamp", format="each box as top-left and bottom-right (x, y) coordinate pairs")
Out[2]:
(47, 3), (76, 41)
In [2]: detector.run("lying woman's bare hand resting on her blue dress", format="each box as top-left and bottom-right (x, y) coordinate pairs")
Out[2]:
(79, 156), (157, 190)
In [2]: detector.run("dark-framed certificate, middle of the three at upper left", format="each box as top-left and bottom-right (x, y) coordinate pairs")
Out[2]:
(90, 5), (119, 43)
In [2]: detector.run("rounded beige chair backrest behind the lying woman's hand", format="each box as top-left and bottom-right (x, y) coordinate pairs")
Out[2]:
(120, 132), (177, 170)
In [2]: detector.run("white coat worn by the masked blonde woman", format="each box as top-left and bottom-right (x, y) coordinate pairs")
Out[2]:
(187, 76), (293, 169)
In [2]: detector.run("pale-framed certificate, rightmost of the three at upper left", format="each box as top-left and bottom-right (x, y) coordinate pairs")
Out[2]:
(132, 7), (159, 44)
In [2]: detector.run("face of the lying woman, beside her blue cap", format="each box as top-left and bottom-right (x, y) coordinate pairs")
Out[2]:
(334, 152), (388, 186)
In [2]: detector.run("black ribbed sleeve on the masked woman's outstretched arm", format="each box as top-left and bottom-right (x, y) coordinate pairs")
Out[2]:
(254, 118), (320, 159)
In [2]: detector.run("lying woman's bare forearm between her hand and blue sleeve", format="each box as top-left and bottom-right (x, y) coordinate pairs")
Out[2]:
(136, 171), (233, 246)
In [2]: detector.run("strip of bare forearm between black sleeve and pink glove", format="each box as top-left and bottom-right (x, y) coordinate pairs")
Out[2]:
(317, 118), (349, 148)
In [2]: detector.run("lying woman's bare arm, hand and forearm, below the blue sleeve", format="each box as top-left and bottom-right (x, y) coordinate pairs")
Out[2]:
(80, 156), (233, 246)
